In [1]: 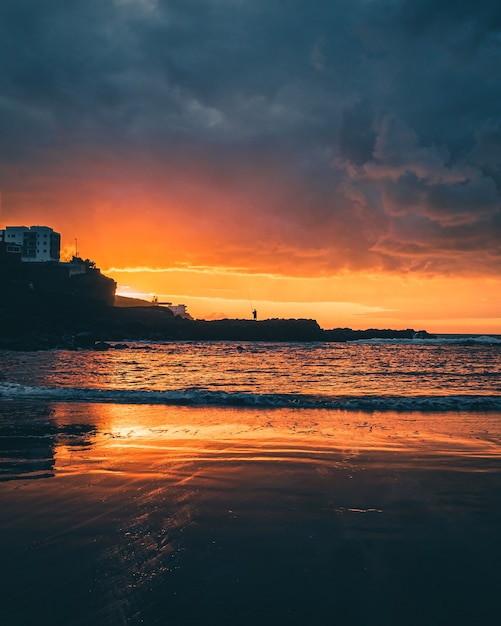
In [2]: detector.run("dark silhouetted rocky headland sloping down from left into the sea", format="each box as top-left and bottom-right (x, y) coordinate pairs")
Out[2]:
(0, 236), (431, 350)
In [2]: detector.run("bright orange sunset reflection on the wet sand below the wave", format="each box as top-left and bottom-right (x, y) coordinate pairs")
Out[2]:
(49, 403), (501, 476)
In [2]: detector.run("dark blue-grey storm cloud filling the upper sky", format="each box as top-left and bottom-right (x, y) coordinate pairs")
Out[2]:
(0, 0), (501, 271)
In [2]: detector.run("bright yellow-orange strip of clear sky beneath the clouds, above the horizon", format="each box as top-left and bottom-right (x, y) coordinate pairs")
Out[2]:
(108, 267), (501, 334)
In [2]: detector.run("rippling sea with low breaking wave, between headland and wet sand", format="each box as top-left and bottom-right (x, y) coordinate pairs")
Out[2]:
(0, 336), (501, 410)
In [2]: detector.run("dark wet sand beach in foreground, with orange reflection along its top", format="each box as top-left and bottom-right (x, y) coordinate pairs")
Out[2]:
(0, 400), (501, 626)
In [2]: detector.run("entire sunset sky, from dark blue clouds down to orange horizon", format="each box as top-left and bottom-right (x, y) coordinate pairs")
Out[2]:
(0, 0), (501, 333)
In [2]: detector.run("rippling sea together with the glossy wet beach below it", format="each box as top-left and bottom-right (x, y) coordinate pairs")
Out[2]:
(0, 335), (501, 626)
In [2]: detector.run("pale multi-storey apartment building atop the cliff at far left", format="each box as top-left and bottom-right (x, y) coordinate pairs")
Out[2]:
(0, 226), (61, 263)
